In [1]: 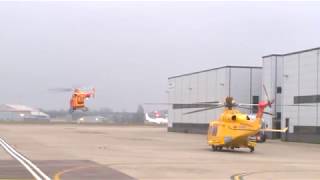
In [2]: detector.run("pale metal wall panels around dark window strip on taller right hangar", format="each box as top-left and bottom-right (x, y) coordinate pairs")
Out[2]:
(282, 50), (320, 132)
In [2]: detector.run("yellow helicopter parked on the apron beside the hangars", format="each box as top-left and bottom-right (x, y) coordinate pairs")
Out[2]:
(185, 87), (288, 152)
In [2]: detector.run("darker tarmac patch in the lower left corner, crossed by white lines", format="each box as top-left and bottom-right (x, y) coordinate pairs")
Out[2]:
(0, 160), (134, 180)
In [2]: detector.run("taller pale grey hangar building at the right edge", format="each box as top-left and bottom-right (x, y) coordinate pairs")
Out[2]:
(263, 47), (320, 143)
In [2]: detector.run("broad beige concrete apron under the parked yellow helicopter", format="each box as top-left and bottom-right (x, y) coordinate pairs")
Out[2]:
(0, 125), (320, 180)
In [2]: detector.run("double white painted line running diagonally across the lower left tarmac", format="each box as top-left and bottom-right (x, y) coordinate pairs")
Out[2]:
(0, 137), (51, 180)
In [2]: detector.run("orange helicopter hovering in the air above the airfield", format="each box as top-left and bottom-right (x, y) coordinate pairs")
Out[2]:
(50, 88), (96, 113)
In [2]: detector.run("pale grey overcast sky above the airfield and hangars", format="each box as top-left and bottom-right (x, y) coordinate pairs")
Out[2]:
(0, 2), (320, 111)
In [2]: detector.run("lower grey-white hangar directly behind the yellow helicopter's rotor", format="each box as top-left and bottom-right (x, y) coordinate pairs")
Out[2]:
(168, 66), (262, 133)
